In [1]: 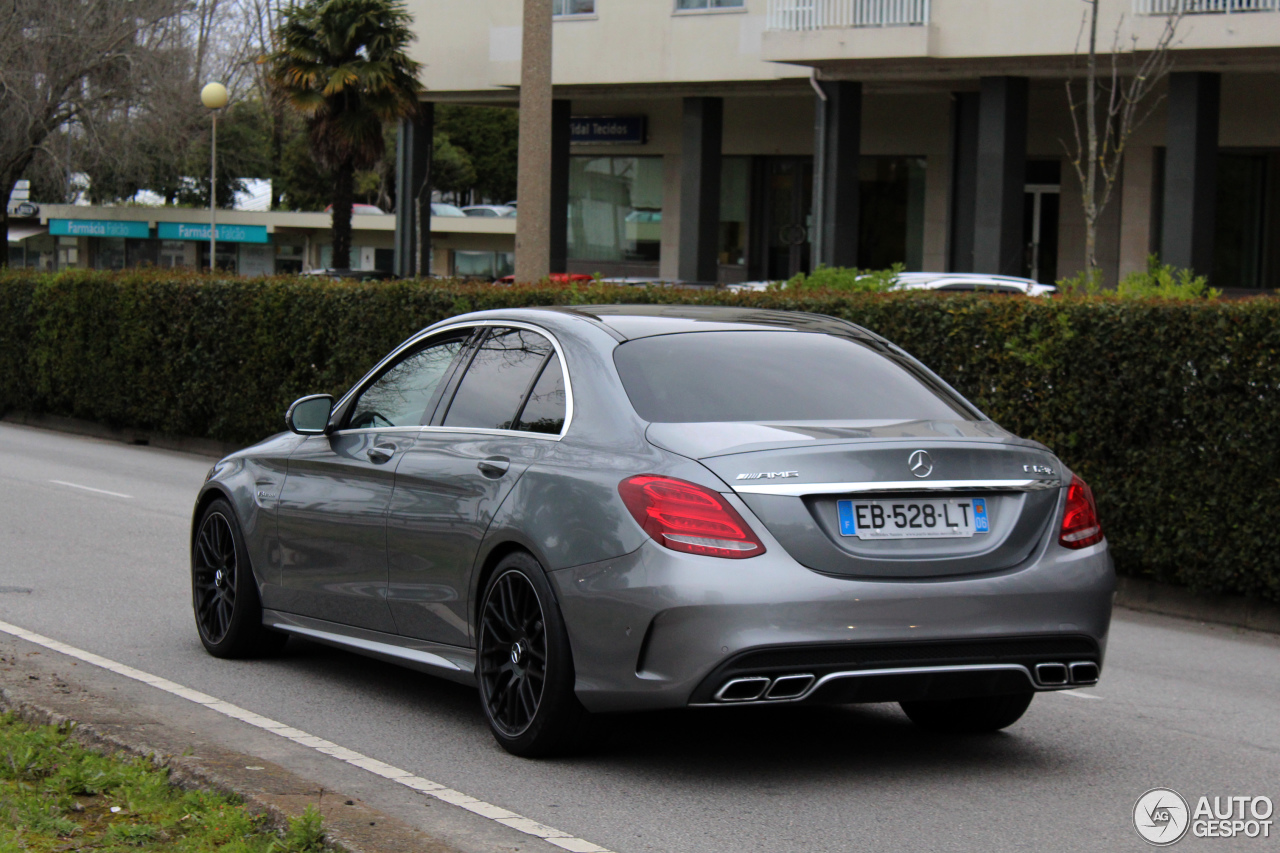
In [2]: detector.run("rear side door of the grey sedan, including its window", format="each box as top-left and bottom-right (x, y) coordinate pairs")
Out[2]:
(387, 327), (567, 646)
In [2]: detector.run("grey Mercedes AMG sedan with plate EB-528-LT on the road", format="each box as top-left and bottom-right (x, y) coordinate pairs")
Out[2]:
(192, 305), (1115, 756)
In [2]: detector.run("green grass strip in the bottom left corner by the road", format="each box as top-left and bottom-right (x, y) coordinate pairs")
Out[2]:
(0, 713), (324, 853)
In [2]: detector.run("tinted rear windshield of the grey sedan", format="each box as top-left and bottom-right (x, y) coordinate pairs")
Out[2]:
(613, 332), (973, 424)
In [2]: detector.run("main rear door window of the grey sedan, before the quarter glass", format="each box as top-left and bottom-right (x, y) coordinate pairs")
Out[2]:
(444, 329), (553, 429)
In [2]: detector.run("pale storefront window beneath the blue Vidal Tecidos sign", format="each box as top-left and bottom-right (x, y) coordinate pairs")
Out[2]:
(568, 156), (663, 261)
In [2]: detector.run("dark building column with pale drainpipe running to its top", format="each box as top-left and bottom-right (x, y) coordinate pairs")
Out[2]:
(814, 81), (863, 266)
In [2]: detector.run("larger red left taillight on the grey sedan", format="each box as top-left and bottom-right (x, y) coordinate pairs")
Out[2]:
(618, 474), (764, 560)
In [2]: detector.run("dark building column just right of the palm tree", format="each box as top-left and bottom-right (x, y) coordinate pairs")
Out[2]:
(394, 102), (435, 278)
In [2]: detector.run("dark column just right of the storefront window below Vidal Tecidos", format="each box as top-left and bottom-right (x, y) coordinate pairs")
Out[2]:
(680, 97), (724, 282)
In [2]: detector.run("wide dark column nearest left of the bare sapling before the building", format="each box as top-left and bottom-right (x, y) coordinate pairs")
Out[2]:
(973, 77), (1028, 275)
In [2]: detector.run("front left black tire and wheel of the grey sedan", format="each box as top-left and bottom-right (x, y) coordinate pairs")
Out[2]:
(191, 498), (289, 658)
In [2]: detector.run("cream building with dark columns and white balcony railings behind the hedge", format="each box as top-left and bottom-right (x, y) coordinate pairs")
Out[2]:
(397, 0), (1280, 288)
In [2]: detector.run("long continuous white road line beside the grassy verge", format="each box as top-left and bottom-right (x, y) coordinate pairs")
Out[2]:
(0, 617), (611, 853)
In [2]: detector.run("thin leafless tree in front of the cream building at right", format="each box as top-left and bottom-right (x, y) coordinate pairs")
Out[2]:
(1062, 0), (1183, 279)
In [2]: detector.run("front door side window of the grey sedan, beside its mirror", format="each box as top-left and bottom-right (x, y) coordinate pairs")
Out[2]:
(347, 336), (467, 429)
